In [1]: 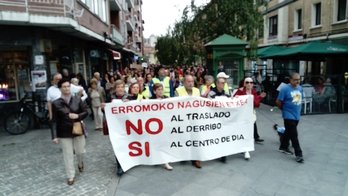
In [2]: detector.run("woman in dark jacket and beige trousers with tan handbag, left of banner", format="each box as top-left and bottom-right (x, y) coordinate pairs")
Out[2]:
(52, 79), (88, 185)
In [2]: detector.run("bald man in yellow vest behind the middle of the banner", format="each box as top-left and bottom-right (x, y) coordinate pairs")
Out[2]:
(175, 75), (202, 168)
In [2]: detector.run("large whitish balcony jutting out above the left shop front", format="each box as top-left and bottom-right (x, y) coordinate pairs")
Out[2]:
(0, 0), (113, 44)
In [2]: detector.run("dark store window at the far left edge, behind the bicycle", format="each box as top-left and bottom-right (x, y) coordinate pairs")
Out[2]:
(0, 51), (30, 103)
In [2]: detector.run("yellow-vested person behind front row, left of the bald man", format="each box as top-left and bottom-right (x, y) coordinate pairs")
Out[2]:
(149, 66), (174, 97)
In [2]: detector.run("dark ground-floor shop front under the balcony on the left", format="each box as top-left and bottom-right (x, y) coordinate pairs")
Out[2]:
(0, 26), (111, 110)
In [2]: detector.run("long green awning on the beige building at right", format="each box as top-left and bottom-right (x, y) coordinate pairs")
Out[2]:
(263, 41), (348, 58)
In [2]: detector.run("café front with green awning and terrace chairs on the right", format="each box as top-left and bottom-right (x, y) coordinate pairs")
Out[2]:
(261, 41), (348, 114)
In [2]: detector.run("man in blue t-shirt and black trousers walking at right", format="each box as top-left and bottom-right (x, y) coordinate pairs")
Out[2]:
(276, 73), (304, 163)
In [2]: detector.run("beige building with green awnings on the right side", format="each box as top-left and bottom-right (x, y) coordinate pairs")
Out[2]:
(259, 0), (348, 113)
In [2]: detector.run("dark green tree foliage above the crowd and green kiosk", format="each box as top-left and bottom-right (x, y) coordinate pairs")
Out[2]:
(156, 0), (265, 64)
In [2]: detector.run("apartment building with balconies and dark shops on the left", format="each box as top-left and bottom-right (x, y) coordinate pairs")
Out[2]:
(0, 0), (144, 107)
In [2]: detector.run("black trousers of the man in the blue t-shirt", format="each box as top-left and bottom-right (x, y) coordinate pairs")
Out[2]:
(280, 119), (302, 156)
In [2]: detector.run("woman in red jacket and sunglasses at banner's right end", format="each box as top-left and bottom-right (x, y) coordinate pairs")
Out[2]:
(234, 77), (266, 160)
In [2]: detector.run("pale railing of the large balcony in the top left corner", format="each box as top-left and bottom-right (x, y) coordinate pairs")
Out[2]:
(0, 0), (83, 18)
